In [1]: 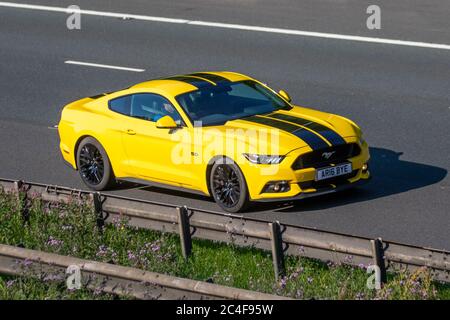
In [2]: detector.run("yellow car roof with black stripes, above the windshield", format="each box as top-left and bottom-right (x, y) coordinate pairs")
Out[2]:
(130, 71), (252, 96)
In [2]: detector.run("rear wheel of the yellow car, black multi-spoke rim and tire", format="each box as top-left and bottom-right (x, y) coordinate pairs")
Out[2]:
(77, 137), (116, 191)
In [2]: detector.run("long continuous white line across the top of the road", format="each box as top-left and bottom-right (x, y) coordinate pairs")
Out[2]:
(0, 1), (450, 50)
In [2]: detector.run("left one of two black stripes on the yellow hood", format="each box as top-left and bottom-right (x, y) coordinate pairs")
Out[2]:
(242, 116), (329, 150)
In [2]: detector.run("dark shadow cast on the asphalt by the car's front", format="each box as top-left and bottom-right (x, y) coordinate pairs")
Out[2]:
(251, 148), (447, 212)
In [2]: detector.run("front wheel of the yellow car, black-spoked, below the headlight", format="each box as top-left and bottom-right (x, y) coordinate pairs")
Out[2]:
(209, 158), (250, 213)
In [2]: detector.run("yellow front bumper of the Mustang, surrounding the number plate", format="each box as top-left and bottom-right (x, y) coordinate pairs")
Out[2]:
(242, 137), (370, 202)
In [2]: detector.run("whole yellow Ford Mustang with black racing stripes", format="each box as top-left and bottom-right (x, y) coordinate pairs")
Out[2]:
(58, 72), (370, 212)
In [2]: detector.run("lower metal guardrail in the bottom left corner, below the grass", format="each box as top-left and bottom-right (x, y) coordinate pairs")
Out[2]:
(0, 244), (288, 300)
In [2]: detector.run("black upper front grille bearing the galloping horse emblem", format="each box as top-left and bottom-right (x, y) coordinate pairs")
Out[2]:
(292, 143), (361, 170)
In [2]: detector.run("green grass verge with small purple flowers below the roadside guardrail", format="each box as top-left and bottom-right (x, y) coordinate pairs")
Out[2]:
(0, 191), (450, 299)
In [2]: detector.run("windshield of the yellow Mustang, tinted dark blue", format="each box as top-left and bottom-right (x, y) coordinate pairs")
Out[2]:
(176, 80), (291, 126)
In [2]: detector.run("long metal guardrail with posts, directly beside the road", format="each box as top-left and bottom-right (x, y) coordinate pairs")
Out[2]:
(0, 179), (450, 282)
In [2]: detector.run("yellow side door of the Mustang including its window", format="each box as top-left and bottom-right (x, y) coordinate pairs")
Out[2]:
(123, 93), (195, 188)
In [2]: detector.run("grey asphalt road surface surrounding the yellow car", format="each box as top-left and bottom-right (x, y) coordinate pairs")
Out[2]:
(0, 0), (450, 249)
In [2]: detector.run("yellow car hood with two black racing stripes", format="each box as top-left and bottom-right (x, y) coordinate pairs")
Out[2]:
(203, 106), (359, 154)
